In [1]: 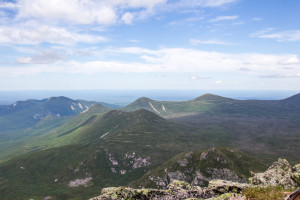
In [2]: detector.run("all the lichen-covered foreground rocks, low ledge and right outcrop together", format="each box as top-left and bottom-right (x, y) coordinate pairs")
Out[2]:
(90, 159), (300, 200)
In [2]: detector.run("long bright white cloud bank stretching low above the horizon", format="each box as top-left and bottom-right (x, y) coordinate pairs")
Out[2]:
(1, 47), (299, 76)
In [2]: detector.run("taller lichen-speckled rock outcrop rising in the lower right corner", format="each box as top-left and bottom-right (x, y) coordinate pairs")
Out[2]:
(249, 159), (300, 188)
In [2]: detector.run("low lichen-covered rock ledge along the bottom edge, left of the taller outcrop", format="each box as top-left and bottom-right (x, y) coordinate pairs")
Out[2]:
(90, 180), (249, 200)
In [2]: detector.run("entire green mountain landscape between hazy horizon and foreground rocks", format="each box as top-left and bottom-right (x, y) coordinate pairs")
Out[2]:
(0, 94), (300, 199)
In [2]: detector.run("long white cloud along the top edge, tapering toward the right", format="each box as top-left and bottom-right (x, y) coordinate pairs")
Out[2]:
(0, 0), (237, 25)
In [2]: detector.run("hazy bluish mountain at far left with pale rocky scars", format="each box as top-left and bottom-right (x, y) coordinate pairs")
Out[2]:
(0, 97), (109, 162)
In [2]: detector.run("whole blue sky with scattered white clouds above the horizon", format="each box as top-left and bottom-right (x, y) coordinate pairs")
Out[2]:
(0, 0), (300, 90)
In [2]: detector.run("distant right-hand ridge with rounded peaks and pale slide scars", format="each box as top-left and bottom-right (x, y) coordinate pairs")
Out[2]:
(122, 94), (300, 118)
